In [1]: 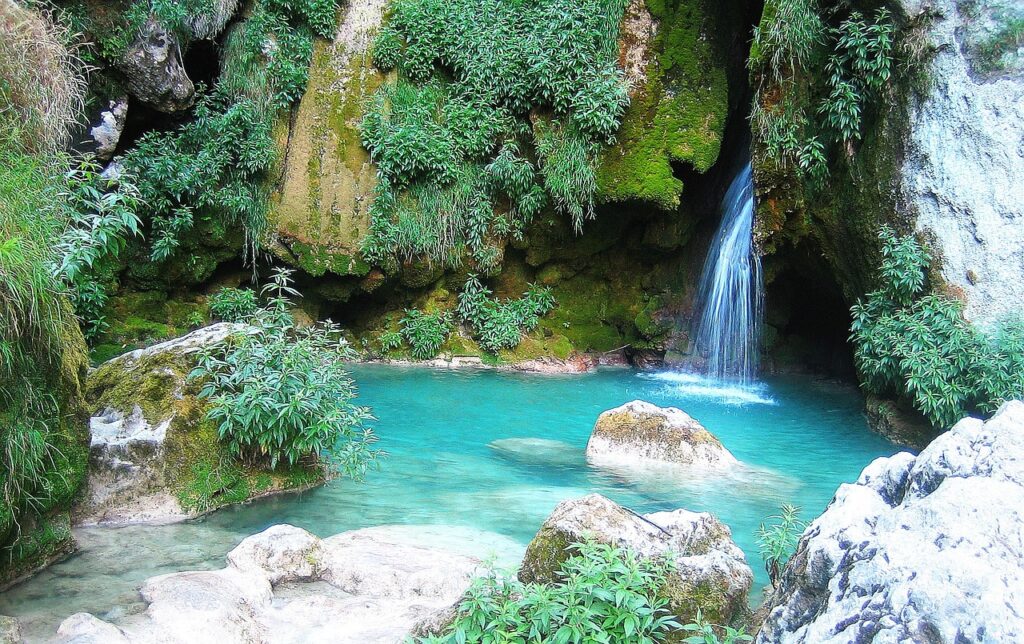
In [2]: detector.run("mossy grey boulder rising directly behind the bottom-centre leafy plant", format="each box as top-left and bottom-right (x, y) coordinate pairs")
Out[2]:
(519, 495), (754, 624)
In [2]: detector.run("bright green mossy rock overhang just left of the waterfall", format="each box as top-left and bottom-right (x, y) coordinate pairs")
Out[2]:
(598, 0), (729, 209)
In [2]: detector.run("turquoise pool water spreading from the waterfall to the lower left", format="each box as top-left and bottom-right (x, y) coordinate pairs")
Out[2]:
(0, 366), (897, 639)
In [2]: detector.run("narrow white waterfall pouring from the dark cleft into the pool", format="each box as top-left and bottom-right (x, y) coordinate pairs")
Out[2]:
(695, 163), (764, 383)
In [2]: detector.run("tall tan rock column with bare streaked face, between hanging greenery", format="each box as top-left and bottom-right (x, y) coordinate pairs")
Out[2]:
(270, 0), (387, 275)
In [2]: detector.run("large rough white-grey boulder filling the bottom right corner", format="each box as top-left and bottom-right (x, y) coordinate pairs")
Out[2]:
(758, 401), (1024, 644)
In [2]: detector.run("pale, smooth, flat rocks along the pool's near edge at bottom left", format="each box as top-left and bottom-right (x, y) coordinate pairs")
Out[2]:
(59, 525), (480, 644)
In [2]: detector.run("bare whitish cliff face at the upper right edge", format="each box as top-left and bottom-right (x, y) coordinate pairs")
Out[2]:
(899, 0), (1024, 325)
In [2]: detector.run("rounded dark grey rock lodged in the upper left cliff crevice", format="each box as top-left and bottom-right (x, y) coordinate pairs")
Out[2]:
(117, 17), (196, 113)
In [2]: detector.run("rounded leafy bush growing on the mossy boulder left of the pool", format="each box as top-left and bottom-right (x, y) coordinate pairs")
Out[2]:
(189, 270), (378, 476)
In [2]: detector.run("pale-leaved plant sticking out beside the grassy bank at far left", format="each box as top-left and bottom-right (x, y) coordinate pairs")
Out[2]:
(56, 159), (141, 340)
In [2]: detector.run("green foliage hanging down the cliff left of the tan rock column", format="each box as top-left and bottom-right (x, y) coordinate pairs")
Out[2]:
(125, 0), (337, 261)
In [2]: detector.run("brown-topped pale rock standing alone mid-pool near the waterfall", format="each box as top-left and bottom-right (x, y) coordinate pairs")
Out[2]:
(587, 400), (739, 468)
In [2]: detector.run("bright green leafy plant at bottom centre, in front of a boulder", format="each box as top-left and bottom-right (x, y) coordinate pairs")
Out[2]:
(420, 543), (680, 644)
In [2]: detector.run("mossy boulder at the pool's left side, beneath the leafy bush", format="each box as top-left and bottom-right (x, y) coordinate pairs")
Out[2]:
(76, 324), (326, 523)
